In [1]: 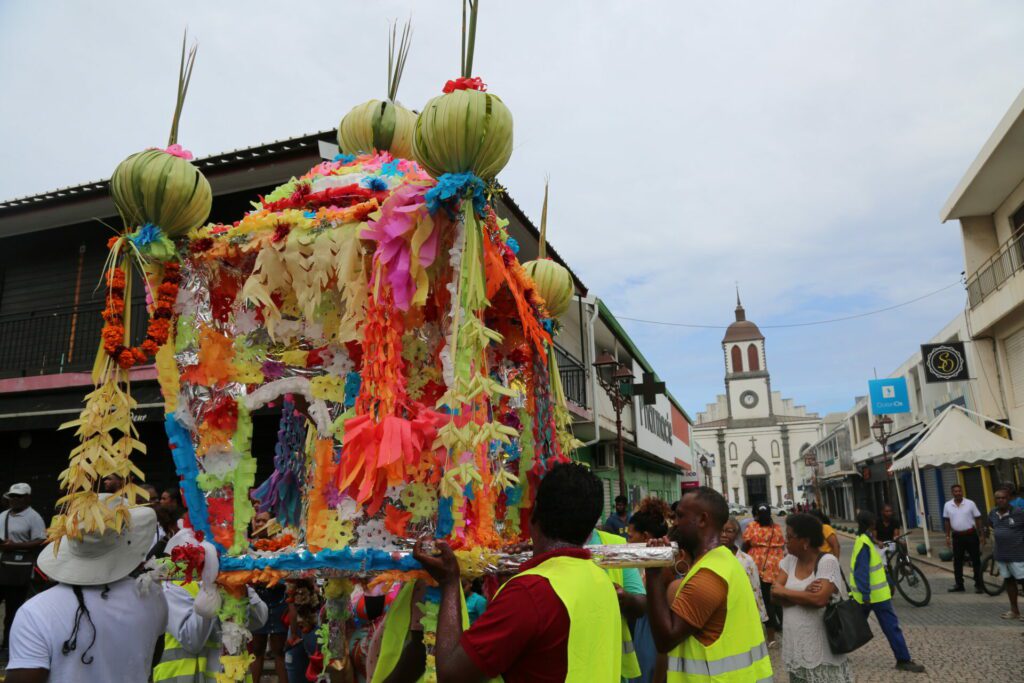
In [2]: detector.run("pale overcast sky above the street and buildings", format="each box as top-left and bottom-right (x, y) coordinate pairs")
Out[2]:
(0, 0), (1024, 417)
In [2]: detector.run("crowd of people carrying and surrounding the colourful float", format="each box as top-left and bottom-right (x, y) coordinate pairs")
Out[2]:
(0, 473), (1024, 683)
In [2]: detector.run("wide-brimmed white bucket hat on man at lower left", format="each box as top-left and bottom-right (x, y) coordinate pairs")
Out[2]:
(39, 494), (157, 586)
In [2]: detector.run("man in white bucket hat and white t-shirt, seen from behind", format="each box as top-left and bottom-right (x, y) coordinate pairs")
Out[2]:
(4, 494), (167, 683)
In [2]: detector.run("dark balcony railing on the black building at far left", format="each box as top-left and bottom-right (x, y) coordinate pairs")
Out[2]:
(0, 301), (146, 378)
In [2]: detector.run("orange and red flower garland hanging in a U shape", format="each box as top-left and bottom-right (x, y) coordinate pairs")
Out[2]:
(101, 261), (181, 370)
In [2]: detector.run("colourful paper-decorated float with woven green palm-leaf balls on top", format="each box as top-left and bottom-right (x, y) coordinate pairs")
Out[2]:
(51, 2), (671, 681)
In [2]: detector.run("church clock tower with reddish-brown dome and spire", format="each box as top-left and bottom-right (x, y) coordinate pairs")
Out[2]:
(722, 291), (773, 422)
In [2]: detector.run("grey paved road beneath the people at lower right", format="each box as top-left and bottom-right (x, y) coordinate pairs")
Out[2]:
(772, 535), (1024, 683)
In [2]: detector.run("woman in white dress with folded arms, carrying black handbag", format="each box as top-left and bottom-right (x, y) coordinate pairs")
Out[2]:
(772, 513), (853, 683)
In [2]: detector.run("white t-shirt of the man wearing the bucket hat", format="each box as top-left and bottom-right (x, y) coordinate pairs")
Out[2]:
(7, 579), (167, 683)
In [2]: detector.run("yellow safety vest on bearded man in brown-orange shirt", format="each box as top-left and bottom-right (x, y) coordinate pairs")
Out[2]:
(668, 546), (772, 683)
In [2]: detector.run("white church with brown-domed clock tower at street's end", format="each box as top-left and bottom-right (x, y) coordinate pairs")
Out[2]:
(693, 292), (824, 508)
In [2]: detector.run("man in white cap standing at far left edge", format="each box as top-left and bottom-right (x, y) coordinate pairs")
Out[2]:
(0, 483), (46, 659)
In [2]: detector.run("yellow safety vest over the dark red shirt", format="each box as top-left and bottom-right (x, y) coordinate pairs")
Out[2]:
(495, 555), (622, 683)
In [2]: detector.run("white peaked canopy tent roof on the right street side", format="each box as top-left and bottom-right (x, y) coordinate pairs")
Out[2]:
(889, 405), (1024, 472)
